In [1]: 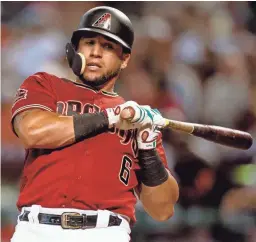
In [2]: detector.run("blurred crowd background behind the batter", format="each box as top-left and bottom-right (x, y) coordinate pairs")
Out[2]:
(1, 1), (256, 242)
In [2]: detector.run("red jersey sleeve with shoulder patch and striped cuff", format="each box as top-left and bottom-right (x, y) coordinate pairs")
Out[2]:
(11, 73), (57, 122)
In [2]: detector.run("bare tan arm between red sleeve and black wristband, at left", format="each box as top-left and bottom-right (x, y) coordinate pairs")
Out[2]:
(14, 109), (75, 149)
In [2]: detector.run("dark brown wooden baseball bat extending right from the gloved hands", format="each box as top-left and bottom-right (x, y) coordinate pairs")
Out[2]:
(165, 119), (253, 150)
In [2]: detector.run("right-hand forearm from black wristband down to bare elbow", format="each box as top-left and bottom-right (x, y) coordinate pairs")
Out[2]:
(138, 149), (179, 221)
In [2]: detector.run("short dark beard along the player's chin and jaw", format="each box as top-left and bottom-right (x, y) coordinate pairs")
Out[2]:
(79, 67), (121, 87)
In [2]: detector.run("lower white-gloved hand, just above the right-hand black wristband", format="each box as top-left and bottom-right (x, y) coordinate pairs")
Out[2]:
(137, 125), (161, 150)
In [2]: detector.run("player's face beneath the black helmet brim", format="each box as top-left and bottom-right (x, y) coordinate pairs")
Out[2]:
(78, 35), (130, 85)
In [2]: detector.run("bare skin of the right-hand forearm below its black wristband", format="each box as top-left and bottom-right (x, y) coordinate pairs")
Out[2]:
(140, 175), (179, 221)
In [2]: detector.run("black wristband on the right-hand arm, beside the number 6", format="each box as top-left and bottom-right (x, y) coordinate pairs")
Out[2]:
(139, 149), (169, 187)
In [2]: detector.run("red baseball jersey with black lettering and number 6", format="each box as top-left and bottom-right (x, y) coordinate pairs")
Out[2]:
(12, 72), (169, 221)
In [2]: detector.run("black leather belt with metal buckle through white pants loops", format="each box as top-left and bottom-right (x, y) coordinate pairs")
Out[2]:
(19, 211), (122, 229)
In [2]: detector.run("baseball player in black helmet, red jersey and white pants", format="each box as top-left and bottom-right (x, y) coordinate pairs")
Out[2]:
(11, 7), (178, 242)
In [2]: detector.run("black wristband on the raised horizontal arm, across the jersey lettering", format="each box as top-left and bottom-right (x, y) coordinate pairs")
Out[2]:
(73, 112), (108, 142)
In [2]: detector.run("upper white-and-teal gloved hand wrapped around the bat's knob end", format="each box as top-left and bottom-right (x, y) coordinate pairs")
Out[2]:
(105, 101), (153, 130)
